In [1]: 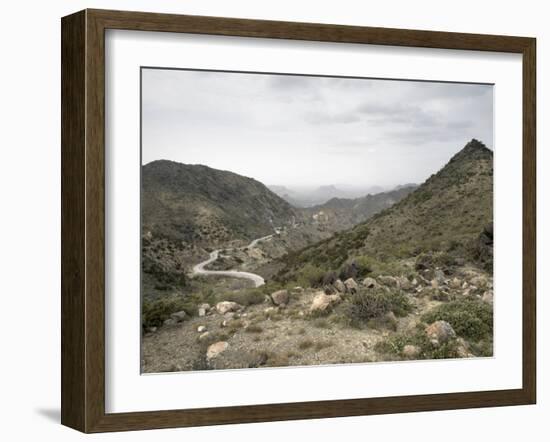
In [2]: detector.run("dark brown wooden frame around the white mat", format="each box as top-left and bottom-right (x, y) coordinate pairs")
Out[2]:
(61, 10), (536, 432)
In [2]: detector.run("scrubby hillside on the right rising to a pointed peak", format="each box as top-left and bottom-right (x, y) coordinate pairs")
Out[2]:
(279, 139), (493, 280)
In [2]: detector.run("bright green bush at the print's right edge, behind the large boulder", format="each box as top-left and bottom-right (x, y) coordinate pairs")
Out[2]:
(422, 300), (493, 341)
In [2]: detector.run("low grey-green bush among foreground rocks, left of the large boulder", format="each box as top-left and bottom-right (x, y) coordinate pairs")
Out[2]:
(347, 290), (412, 324)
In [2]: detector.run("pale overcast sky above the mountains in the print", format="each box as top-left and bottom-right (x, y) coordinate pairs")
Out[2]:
(142, 69), (493, 187)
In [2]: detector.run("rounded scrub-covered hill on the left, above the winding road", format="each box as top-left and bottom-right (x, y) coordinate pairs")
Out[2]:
(142, 160), (295, 246)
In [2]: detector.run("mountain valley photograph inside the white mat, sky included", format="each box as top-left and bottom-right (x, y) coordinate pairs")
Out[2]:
(140, 66), (494, 374)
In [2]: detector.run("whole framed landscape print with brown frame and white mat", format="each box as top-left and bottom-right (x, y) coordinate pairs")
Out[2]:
(62, 10), (536, 432)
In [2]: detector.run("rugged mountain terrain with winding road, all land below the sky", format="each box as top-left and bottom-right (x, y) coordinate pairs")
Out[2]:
(141, 140), (493, 372)
